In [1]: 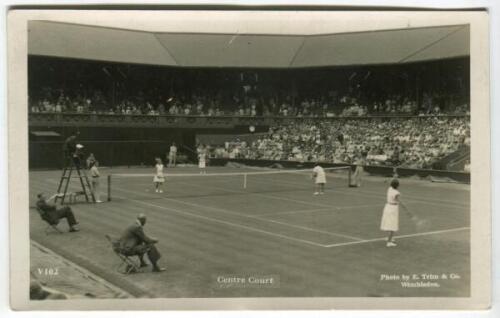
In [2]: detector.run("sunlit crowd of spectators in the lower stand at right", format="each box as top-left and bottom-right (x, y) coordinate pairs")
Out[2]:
(211, 117), (470, 169)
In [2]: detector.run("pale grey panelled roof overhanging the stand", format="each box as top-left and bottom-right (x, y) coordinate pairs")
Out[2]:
(28, 21), (470, 68)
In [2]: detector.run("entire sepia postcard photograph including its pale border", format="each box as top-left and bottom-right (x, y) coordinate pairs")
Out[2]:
(9, 10), (491, 309)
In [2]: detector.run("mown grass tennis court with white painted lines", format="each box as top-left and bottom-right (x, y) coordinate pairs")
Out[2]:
(30, 167), (470, 297)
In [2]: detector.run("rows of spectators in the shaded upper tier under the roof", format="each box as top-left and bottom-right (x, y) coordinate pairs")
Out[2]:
(29, 90), (469, 117)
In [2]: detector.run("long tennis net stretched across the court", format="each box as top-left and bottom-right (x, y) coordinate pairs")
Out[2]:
(107, 166), (351, 201)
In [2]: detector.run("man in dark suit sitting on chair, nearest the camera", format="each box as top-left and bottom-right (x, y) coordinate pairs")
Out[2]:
(119, 213), (165, 272)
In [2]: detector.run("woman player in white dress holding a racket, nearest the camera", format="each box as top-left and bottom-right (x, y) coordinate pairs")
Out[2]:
(380, 179), (408, 247)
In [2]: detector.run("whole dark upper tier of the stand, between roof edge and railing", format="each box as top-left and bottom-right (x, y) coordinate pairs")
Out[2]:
(28, 57), (469, 117)
